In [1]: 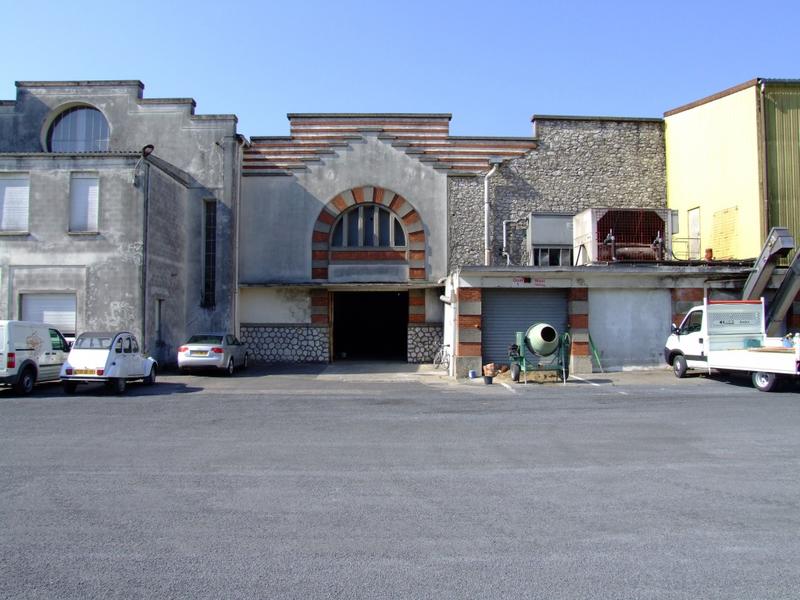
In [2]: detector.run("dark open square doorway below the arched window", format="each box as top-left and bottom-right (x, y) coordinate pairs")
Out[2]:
(333, 292), (408, 361)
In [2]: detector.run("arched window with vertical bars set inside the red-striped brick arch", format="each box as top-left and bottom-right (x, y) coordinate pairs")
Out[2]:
(331, 204), (406, 248)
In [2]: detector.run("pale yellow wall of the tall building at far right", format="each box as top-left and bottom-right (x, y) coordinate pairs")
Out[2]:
(664, 83), (766, 259)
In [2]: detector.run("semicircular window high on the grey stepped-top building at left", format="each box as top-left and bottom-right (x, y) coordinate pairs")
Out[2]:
(47, 106), (109, 152)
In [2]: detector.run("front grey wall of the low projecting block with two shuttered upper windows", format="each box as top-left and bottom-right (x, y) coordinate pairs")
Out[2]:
(0, 156), (143, 333)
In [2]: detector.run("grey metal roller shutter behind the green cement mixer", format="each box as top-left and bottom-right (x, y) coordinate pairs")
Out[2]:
(481, 288), (568, 363)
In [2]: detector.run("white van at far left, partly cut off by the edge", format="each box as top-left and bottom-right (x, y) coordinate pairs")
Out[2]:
(0, 321), (69, 394)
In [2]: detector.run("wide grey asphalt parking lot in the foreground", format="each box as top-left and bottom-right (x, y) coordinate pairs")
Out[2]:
(0, 365), (800, 599)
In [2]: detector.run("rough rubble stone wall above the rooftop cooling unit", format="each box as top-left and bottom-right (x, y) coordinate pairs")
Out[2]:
(448, 119), (667, 270)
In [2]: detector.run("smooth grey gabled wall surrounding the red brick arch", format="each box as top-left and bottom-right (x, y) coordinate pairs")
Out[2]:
(239, 134), (447, 284)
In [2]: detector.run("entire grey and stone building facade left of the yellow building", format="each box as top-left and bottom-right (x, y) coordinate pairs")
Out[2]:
(0, 81), (788, 376)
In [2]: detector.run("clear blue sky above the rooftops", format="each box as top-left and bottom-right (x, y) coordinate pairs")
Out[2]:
(0, 0), (800, 136)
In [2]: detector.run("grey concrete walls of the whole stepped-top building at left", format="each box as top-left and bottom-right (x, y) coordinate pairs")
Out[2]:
(0, 81), (240, 350)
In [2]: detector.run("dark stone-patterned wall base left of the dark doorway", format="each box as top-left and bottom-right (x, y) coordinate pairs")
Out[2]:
(240, 325), (328, 363)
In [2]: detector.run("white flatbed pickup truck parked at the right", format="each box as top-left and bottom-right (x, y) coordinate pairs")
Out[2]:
(664, 298), (800, 392)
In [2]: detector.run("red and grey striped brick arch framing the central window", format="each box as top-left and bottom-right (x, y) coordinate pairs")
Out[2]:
(311, 186), (427, 280)
